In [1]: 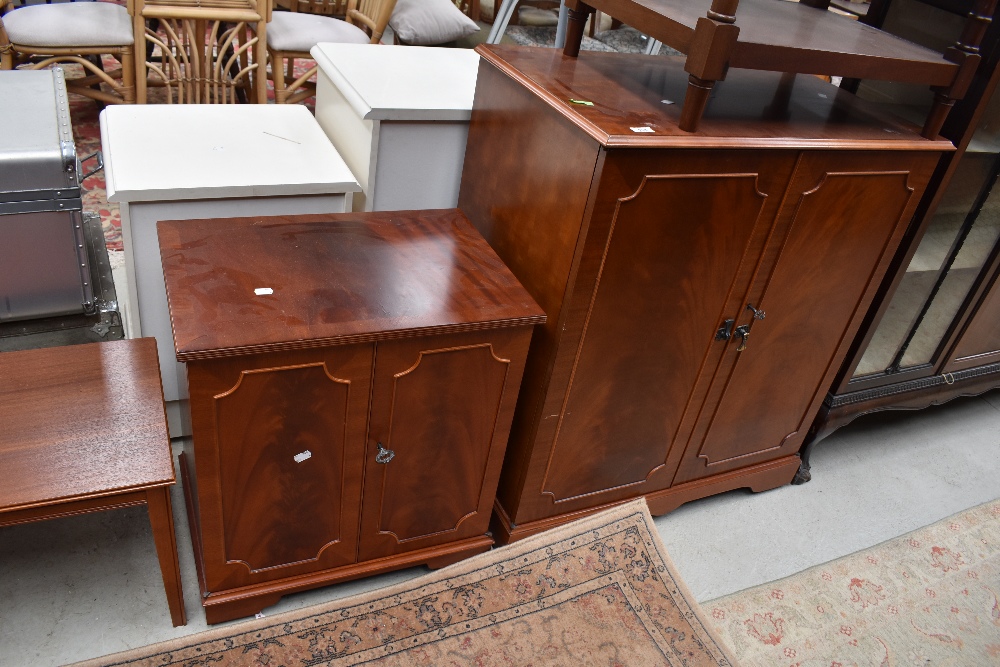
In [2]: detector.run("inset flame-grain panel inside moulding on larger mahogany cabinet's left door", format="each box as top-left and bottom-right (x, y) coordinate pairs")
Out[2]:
(542, 173), (774, 503)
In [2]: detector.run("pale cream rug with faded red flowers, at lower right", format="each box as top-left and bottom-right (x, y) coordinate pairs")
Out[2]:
(703, 500), (1000, 667)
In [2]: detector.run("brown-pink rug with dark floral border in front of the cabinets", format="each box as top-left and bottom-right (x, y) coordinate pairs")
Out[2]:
(74, 500), (735, 667)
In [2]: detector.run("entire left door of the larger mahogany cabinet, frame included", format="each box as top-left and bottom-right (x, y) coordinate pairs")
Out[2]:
(544, 157), (794, 508)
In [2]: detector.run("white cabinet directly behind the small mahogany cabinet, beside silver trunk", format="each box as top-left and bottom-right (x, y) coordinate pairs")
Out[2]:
(101, 104), (361, 437)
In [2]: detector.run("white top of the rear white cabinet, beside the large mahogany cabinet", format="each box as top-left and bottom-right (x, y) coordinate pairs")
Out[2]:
(310, 43), (479, 121)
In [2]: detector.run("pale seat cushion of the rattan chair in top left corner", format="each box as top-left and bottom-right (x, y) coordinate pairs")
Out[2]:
(3, 2), (134, 47)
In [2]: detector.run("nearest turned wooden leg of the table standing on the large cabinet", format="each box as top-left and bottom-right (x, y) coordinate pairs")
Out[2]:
(679, 0), (744, 132)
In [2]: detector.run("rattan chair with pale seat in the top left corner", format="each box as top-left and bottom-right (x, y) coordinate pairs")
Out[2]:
(0, 0), (136, 104)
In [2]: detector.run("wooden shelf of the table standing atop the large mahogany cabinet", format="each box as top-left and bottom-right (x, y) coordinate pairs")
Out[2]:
(587, 0), (956, 85)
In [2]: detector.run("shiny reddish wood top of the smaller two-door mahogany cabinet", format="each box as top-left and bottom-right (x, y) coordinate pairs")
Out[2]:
(157, 209), (545, 361)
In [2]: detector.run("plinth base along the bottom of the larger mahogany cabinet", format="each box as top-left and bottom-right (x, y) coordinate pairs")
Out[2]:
(490, 455), (801, 544)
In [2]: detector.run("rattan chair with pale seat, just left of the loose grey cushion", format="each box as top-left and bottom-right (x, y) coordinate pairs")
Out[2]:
(267, 0), (396, 104)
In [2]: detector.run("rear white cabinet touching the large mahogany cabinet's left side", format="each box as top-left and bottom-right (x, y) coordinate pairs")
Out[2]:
(310, 43), (479, 211)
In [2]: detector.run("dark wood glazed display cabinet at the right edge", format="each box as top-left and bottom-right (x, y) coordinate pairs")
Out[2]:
(796, 0), (1000, 482)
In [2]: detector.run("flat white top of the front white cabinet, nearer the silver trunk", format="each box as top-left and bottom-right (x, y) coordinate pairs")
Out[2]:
(101, 104), (361, 202)
